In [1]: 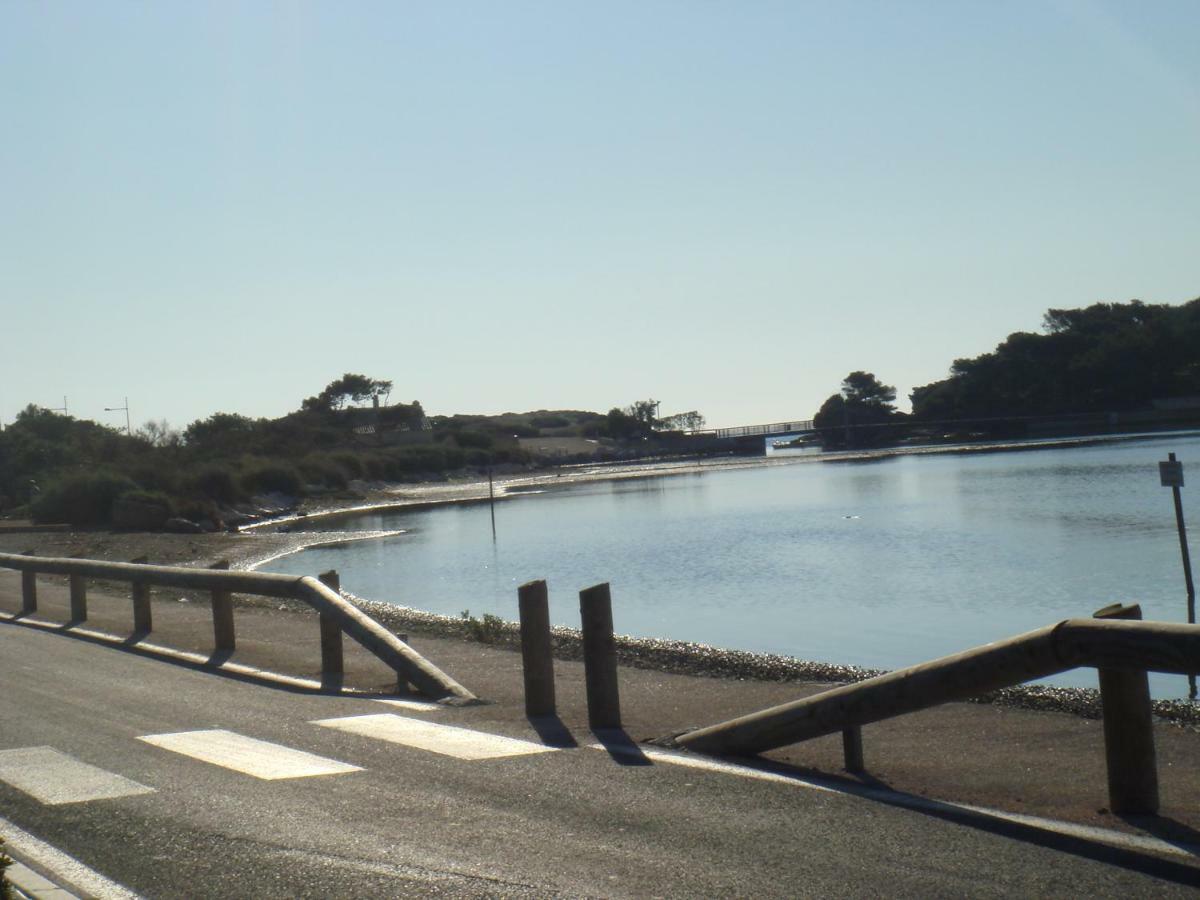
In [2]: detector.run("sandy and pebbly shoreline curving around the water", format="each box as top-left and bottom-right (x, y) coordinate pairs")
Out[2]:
(0, 432), (1200, 732)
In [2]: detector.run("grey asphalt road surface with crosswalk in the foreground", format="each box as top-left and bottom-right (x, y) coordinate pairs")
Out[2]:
(0, 624), (1200, 898)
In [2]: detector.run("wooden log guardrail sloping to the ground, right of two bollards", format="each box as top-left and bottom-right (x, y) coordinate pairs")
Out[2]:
(674, 606), (1200, 812)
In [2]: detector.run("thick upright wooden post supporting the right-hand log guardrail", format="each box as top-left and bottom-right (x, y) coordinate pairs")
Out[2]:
(1094, 604), (1158, 812)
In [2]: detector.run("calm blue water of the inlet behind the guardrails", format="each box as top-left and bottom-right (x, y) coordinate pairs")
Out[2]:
(265, 436), (1200, 696)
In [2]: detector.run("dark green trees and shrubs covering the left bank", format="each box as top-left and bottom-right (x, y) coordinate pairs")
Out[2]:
(0, 373), (710, 530)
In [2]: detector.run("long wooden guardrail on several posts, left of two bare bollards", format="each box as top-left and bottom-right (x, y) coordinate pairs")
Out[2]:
(0, 553), (476, 704)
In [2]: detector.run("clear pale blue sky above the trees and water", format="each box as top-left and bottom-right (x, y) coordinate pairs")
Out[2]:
(0, 0), (1200, 427)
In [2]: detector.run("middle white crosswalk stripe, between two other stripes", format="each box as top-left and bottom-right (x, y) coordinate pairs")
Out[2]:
(138, 728), (361, 781)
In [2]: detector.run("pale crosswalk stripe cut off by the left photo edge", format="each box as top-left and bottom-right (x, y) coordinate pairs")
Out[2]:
(0, 746), (154, 806)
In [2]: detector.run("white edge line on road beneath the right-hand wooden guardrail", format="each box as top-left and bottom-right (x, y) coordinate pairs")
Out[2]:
(588, 744), (1200, 859)
